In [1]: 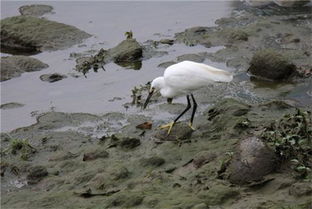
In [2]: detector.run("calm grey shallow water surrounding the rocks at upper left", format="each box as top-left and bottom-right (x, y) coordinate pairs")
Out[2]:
(1, 1), (238, 131)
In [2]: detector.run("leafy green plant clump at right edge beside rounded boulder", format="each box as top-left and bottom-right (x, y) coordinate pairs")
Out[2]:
(262, 109), (312, 178)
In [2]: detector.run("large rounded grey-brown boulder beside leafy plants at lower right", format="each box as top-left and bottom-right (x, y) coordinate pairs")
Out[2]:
(227, 137), (278, 184)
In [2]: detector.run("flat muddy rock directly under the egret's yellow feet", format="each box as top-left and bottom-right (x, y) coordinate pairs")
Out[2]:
(154, 122), (193, 142)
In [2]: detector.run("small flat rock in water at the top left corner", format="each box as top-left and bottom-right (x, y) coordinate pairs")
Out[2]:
(18, 4), (53, 17)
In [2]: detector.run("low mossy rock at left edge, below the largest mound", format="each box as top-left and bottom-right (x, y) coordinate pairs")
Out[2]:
(1, 55), (49, 81)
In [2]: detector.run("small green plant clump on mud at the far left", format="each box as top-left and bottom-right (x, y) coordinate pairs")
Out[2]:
(10, 139), (36, 160)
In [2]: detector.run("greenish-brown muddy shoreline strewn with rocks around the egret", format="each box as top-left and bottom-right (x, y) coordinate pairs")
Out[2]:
(1, 1), (312, 209)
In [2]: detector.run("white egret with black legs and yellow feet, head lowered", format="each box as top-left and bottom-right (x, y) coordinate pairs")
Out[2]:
(143, 61), (233, 135)
